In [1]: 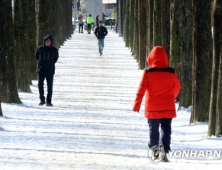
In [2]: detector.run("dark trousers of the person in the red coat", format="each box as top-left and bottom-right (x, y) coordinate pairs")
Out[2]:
(148, 118), (172, 153)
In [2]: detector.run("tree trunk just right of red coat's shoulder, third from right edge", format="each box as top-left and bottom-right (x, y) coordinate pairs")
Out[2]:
(179, 0), (192, 107)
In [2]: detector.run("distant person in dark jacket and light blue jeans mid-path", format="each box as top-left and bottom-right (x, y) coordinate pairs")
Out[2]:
(94, 21), (108, 55)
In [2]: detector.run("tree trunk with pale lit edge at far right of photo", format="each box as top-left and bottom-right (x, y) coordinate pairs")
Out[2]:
(208, 0), (222, 136)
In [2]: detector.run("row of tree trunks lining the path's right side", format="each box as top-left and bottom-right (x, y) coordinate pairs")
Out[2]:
(117, 0), (222, 136)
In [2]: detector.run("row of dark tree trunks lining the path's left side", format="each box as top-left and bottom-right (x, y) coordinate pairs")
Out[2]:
(0, 0), (73, 116)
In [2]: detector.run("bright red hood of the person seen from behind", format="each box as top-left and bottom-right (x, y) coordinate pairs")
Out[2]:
(146, 46), (169, 68)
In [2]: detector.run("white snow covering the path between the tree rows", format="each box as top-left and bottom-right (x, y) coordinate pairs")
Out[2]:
(0, 30), (222, 170)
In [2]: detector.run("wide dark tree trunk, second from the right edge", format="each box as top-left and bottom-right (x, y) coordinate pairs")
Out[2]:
(190, 0), (212, 123)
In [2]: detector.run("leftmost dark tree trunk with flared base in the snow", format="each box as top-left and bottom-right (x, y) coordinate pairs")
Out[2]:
(0, 0), (21, 103)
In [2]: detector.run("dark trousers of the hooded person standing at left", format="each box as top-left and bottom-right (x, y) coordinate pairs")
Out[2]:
(38, 74), (54, 103)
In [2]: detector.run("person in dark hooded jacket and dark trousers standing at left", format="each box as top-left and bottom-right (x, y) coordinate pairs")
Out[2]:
(35, 34), (59, 106)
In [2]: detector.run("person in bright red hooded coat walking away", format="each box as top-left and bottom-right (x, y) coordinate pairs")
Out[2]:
(133, 46), (181, 162)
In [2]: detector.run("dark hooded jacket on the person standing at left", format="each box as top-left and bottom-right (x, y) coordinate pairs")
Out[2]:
(35, 34), (59, 75)
